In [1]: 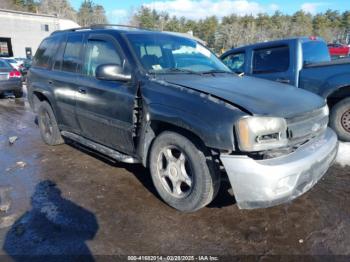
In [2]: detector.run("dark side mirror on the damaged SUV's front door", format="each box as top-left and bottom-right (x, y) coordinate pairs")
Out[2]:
(95, 64), (131, 82)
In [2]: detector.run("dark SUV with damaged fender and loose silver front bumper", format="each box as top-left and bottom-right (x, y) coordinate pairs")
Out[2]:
(28, 26), (338, 212)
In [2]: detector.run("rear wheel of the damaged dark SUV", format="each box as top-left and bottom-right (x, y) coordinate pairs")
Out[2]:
(38, 101), (64, 146)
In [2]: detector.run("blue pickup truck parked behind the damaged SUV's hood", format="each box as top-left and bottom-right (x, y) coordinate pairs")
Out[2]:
(221, 37), (350, 142)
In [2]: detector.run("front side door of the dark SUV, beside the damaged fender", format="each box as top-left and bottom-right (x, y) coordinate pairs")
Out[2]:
(76, 34), (136, 153)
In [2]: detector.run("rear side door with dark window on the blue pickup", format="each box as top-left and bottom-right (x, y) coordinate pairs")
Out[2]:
(251, 43), (296, 85)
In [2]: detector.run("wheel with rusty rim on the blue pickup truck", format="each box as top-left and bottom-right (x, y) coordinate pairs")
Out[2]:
(329, 98), (350, 142)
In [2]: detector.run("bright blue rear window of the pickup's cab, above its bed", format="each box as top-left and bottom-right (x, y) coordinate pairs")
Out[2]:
(303, 41), (331, 64)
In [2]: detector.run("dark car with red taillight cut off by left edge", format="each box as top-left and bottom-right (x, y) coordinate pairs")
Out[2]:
(0, 58), (23, 97)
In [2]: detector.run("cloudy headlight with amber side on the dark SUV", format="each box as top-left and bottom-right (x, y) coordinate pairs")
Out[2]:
(236, 116), (288, 152)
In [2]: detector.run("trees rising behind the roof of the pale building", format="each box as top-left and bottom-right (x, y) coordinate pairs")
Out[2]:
(0, 0), (107, 26)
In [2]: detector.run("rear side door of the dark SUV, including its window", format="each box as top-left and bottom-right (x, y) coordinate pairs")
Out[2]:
(49, 33), (83, 134)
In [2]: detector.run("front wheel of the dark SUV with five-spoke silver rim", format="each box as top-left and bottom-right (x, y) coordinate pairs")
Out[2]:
(150, 131), (220, 212)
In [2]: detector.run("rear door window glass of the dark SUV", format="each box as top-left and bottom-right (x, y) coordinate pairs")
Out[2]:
(62, 34), (83, 73)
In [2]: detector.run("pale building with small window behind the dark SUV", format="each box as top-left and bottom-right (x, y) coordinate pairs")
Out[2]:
(0, 9), (79, 57)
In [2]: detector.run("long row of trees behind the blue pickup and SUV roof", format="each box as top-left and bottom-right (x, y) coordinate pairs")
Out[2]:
(130, 7), (350, 52)
